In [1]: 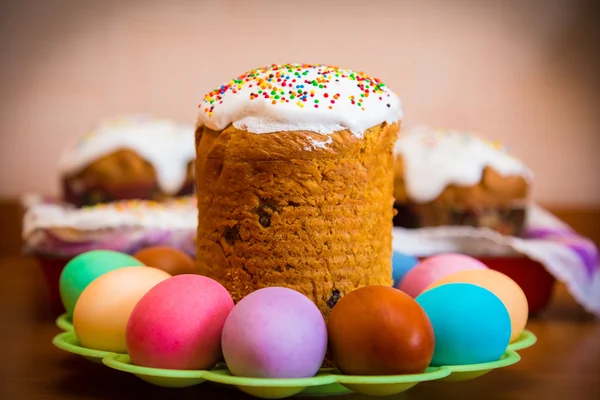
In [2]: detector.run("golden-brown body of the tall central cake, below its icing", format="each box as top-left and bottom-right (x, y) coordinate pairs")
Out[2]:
(196, 123), (399, 318)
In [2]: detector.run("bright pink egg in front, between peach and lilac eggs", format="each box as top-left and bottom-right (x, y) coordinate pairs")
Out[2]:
(126, 274), (233, 370)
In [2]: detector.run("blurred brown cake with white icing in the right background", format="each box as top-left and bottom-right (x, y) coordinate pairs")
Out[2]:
(394, 126), (533, 236)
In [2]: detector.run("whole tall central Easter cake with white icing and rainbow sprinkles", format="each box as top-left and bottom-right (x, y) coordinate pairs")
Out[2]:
(195, 64), (402, 318)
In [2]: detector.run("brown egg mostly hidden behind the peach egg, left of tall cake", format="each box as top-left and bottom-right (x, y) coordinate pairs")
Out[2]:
(133, 246), (196, 276)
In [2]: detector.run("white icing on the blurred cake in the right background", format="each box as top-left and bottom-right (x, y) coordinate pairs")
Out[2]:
(395, 126), (533, 203)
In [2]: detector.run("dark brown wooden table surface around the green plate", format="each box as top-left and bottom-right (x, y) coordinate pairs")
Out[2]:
(0, 257), (600, 400)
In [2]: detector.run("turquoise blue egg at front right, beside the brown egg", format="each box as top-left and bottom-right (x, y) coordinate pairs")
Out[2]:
(416, 283), (511, 366)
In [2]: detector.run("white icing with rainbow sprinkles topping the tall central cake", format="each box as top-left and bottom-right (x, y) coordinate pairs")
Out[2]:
(198, 64), (402, 137)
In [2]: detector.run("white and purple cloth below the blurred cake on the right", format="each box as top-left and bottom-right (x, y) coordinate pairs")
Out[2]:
(393, 204), (600, 316)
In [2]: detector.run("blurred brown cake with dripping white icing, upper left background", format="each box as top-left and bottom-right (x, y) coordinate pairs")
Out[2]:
(60, 115), (195, 207)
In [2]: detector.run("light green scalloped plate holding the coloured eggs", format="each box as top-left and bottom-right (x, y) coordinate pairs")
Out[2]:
(52, 331), (537, 399)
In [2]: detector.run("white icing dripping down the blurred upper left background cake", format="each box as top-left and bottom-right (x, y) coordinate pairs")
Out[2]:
(60, 115), (196, 194)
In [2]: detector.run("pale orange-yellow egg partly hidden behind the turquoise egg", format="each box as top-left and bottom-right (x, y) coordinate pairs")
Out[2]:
(425, 269), (529, 342)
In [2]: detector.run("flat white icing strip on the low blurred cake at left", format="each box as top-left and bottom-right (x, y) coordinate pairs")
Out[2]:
(23, 196), (198, 233)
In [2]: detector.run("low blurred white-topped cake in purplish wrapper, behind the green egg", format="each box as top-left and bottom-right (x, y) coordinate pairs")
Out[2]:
(22, 196), (197, 260)
